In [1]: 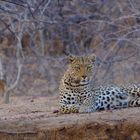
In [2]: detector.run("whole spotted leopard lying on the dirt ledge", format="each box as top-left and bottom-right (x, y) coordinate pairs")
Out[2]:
(59, 54), (140, 114)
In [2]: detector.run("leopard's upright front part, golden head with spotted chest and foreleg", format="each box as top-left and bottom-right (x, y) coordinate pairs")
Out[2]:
(59, 55), (95, 113)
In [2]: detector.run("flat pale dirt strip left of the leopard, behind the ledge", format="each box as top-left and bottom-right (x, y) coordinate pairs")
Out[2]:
(0, 96), (58, 119)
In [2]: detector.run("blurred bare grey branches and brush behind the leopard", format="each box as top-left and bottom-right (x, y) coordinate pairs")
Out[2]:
(0, 0), (140, 96)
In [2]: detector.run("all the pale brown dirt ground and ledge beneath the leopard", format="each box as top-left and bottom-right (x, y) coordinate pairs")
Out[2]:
(0, 96), (140, 140)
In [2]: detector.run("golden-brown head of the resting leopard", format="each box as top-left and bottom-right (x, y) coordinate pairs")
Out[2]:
(64, 54), (96, 86)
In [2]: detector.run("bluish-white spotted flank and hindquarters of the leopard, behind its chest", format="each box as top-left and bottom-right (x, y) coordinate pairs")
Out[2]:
(79, 85), (140, 113)
